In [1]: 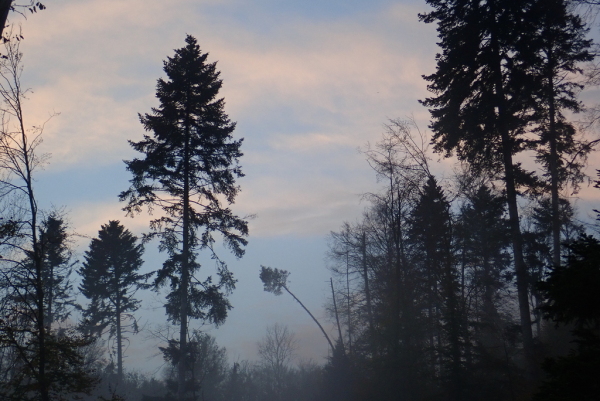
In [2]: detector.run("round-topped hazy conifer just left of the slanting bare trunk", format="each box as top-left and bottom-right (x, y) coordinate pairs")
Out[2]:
(455, 184), (516, 400)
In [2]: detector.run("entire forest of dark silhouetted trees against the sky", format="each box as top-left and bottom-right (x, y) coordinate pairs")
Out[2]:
(0, 0), (600, 401)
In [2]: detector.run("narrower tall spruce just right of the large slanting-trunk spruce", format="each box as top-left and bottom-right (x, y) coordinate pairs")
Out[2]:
(521, 0), (593, 266)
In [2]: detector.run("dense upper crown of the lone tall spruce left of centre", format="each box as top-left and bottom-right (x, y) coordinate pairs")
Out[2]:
(120, 35), (248, 257)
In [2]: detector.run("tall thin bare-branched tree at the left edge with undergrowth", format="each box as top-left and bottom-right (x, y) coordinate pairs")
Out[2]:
(0, 28), (95, 401)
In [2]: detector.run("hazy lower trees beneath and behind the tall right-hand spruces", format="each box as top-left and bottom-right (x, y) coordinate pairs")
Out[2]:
(330, 121), (585, 400)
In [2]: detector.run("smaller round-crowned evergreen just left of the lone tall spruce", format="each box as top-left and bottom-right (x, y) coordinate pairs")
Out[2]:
(78, 220), (150, 381)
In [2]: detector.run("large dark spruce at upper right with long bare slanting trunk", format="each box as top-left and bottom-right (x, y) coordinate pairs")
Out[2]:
(421, 0), (536, 375)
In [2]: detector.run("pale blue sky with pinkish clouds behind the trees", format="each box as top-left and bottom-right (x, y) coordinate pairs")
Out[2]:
(10, 0), (597, 372)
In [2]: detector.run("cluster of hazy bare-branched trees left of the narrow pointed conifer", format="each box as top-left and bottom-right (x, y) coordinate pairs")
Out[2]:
(331, 124), (434, 400)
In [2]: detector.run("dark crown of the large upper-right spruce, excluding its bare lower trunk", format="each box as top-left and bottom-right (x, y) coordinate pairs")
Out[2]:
(421, 0), (531, 171)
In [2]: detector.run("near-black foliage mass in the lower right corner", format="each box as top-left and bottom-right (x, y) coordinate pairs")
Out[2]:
(534, 235), (600, 401)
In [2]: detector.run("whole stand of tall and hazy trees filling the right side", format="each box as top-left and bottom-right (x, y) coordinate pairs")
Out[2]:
(324, 0), (600, 400)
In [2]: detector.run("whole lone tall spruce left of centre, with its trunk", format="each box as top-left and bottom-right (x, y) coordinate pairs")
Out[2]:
(120, 35), (248, 400)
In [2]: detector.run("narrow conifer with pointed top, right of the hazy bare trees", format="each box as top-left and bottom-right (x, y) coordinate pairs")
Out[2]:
(410, 176), (466, 400)
